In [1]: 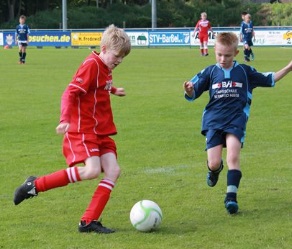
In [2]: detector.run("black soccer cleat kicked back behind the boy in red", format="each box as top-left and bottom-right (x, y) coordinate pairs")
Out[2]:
(14, 176), (38, 205)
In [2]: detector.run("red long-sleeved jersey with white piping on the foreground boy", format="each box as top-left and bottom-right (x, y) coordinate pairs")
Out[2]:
(60, 51), (117, 135)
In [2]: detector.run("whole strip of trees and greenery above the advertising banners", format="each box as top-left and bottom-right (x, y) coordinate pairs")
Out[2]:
(0, 0), (292, 29)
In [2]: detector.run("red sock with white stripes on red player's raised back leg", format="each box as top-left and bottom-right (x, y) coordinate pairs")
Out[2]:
(34, 167), (81, 192)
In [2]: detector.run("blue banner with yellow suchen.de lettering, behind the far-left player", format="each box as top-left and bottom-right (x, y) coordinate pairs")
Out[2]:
(3, 31), (71, 47)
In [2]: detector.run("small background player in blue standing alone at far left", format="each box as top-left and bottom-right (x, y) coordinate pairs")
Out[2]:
(15, 15), (30, 64)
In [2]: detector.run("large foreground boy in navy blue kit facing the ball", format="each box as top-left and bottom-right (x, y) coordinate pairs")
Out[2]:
(183, 33), (292, 214)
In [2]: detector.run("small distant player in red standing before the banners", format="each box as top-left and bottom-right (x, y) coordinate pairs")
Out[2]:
(193, 12), (213, 56)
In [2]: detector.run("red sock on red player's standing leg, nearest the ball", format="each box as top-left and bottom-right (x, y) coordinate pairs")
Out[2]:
(81, 179), (115, 224)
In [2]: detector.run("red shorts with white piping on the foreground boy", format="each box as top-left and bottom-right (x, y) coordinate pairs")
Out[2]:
(63, 132), (117, 167)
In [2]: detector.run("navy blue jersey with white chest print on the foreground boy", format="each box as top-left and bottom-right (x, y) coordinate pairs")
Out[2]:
(185, 61), (275, 138)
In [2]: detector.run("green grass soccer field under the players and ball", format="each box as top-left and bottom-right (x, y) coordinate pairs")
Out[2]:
(0, 47), (292, 249)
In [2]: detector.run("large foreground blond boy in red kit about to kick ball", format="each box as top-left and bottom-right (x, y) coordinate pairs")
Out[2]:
(14, 25), (131, 233)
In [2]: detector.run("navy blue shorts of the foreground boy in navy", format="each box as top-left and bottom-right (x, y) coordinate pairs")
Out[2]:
(205, 127), (245, 150)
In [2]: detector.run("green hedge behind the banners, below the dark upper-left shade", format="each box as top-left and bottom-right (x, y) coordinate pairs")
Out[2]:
(0, 0), (292, 29)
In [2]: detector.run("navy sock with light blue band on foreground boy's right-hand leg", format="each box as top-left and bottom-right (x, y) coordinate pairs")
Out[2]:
(225, 169), (242, 201)
